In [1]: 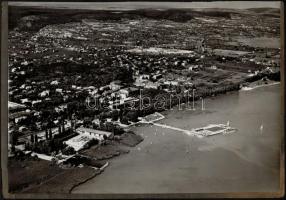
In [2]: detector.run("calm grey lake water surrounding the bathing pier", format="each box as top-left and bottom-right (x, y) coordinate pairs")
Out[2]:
(73, 85), (282, 194)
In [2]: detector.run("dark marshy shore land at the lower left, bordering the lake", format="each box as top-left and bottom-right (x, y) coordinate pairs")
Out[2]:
(9, 132), (143, 193)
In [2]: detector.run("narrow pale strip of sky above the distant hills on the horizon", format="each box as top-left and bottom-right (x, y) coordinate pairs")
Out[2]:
(9, 1), (280, 10)
